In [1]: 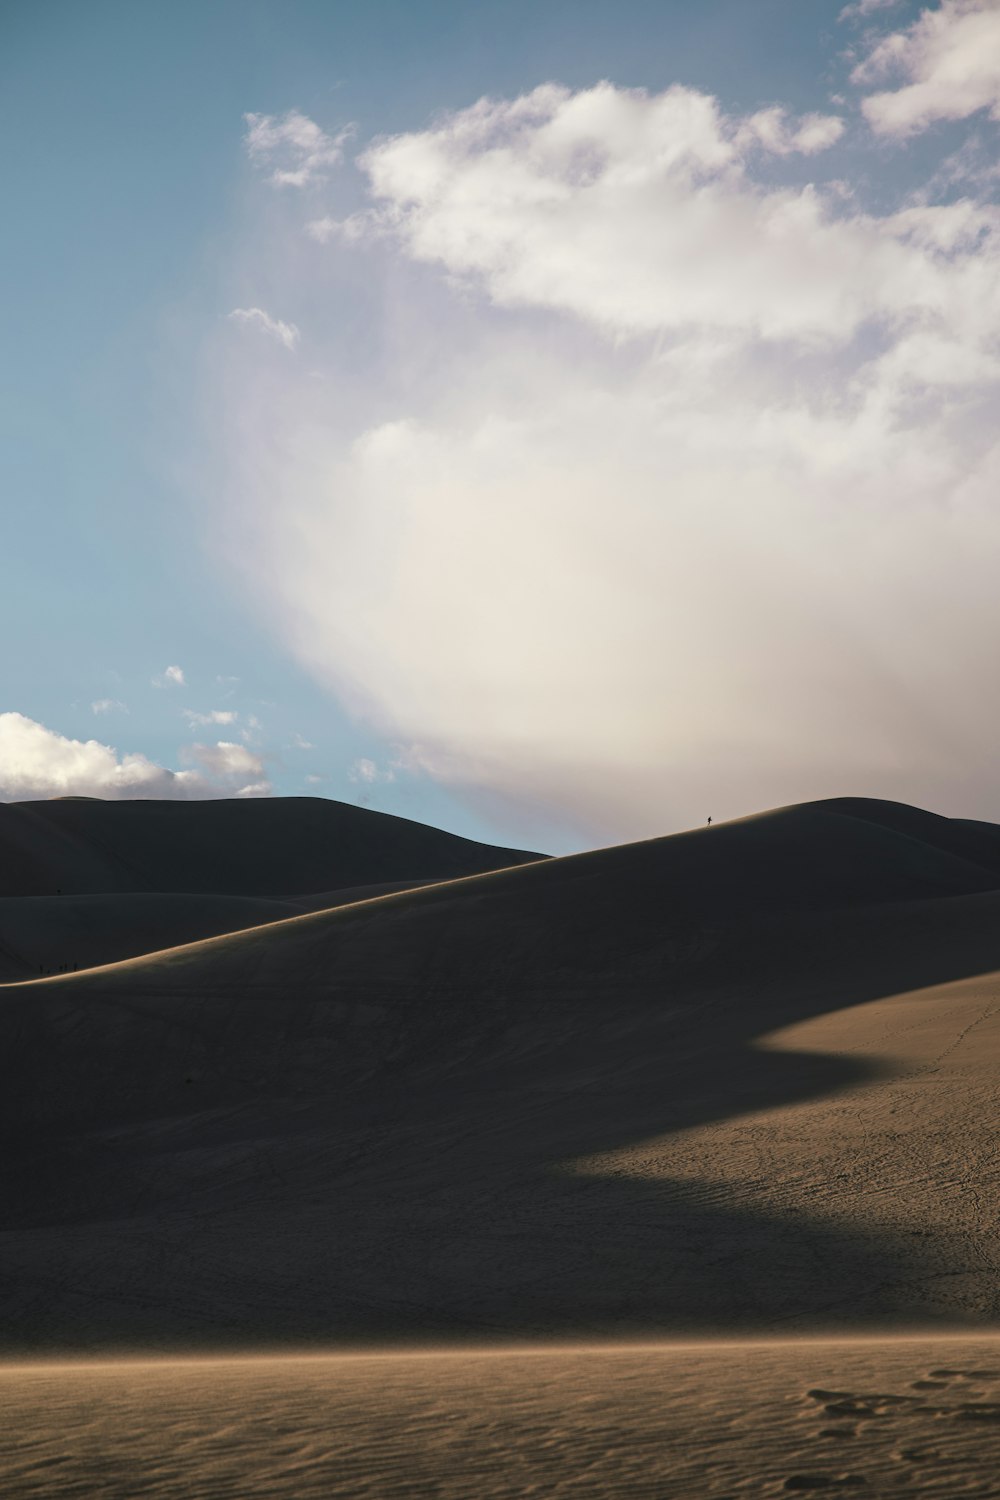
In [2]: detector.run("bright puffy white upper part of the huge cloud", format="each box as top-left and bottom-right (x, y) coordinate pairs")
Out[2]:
(352, 84), (999, 344)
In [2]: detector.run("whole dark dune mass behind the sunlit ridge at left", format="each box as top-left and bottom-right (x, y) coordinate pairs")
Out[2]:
(0, 797), (538, 983)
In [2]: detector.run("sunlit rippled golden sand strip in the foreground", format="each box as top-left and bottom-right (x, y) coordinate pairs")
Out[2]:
(0, 1338), (1000, 1500)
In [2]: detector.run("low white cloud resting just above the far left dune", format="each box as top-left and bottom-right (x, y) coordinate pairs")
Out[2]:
(0, 713), (270, 801)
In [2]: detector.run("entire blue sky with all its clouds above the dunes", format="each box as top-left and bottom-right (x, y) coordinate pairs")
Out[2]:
(0, 0), (1000, 852)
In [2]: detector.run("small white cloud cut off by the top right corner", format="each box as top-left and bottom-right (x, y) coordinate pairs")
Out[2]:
(852, 0), (1000, 138)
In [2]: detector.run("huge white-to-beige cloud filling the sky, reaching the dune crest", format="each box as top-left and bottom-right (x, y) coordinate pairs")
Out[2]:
(212, 84), (1000, 839)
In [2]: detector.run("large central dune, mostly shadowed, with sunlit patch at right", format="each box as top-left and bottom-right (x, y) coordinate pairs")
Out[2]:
(0, 801), (1000, 1349)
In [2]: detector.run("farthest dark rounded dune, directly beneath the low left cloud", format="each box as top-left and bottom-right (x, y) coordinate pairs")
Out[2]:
(0, 797), (540, 899)
